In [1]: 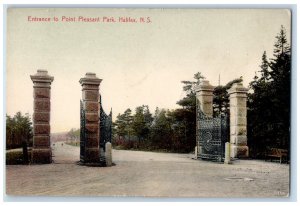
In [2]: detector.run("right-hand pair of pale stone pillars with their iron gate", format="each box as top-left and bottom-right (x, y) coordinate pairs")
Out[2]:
(195, 80), (248, 162)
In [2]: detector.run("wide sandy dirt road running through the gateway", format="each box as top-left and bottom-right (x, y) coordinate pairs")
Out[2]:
(6, 143), (289, 198)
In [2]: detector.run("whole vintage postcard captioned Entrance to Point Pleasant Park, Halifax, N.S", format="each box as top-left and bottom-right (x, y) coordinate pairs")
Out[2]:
(5, 6), (294, 198)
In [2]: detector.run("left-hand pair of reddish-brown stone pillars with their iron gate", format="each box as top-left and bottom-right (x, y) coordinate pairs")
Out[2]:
(30, 70), (112, 166)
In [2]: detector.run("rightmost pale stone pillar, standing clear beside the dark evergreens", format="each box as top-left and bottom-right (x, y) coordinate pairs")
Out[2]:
(228, 83), (249, 158)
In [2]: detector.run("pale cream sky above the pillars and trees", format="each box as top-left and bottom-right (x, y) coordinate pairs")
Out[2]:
(5, 8), (291, 132)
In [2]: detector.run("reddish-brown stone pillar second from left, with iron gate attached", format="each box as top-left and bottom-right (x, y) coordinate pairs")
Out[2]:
(79, 73), (102, 163)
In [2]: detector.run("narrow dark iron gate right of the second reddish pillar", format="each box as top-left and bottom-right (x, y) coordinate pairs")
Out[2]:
(99, 95), (112, 164)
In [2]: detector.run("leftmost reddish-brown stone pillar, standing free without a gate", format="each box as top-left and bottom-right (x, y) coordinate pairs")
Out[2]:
(30, 70), (54, 164)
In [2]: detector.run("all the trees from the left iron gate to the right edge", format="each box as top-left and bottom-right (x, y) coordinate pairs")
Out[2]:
(113, 27), (291, 157)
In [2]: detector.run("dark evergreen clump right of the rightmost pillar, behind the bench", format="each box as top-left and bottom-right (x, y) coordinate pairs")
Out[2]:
(248, 27), (291, 157)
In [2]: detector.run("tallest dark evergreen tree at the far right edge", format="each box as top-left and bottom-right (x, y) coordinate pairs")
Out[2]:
(269, 26), (291, 149)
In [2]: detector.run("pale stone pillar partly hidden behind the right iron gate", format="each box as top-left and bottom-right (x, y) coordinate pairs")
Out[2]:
(195, 80), (215, 158)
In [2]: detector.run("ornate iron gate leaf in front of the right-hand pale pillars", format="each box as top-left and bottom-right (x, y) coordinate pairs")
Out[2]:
(197, 107), (228, 162)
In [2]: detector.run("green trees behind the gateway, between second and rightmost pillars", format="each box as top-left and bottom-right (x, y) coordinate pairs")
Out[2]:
(113, 72), (234, 152)
